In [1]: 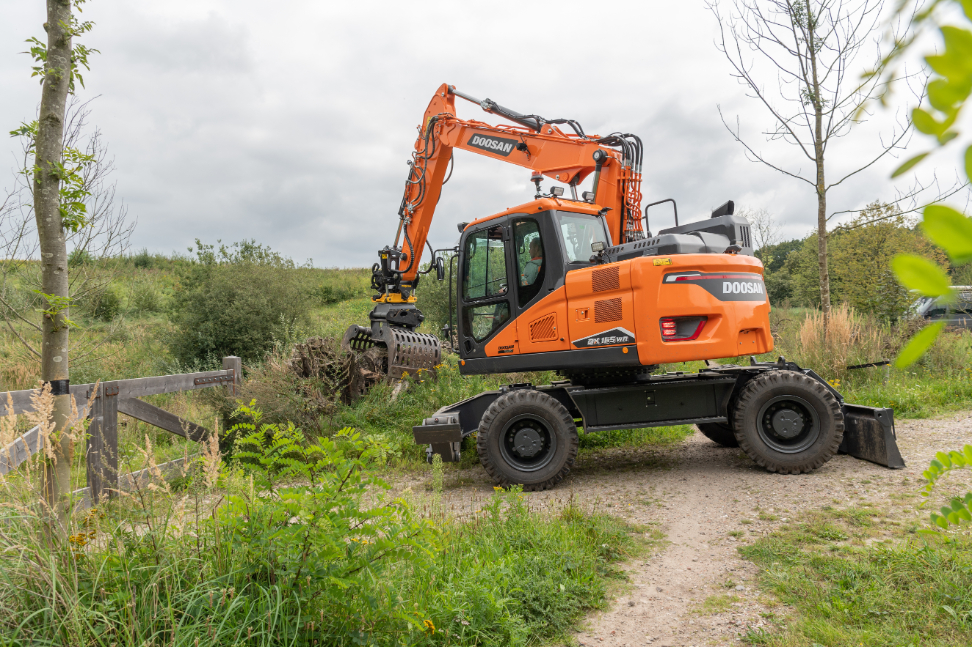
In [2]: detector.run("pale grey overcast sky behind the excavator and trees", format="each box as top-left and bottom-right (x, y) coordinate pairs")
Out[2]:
(0, 0), (968, 267)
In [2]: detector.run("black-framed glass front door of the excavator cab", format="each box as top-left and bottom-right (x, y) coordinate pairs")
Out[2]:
(458, 221), (516, 359)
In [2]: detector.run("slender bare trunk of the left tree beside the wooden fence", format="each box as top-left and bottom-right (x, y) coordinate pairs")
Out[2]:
(34, 0), (74, 534)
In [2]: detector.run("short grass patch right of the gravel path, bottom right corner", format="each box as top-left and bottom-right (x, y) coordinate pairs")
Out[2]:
(740, 507), (972, 647)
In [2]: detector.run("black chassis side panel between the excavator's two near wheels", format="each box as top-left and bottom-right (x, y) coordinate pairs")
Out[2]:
(567, 376), (737, 433)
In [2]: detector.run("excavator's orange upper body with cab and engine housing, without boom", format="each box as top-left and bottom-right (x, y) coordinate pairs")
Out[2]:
(456, 196), (773, 383)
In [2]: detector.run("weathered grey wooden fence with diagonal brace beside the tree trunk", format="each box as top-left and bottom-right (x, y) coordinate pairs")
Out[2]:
(0, 356), (243, 505)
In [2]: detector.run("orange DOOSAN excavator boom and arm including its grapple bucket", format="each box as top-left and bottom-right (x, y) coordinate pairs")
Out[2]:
(344, 84), (644, 378)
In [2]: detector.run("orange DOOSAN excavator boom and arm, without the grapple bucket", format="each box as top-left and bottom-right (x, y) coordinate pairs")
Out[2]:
(374, 84), (644, 303)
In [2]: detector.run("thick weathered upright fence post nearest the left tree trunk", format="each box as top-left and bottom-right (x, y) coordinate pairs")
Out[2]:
(86, 383), (118, 506)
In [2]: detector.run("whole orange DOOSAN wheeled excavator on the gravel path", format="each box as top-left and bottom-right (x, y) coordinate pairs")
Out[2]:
(344, 85), (904, 490)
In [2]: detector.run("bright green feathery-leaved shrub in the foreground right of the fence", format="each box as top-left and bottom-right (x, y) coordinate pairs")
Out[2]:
(219, 402), (440, 631)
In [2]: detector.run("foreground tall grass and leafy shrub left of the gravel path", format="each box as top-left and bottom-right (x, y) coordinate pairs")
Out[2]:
(0, 402), (639, 647)
